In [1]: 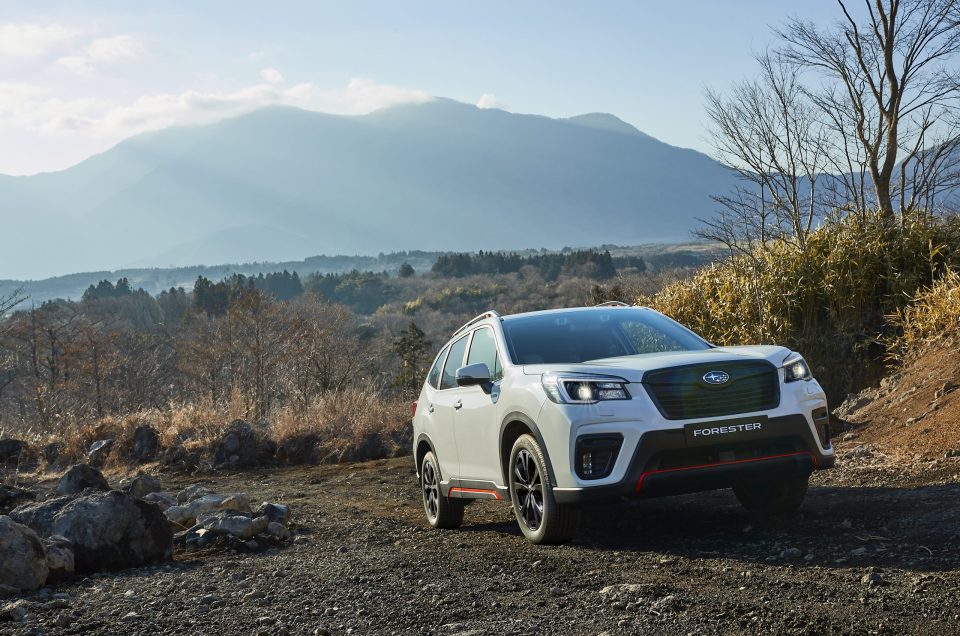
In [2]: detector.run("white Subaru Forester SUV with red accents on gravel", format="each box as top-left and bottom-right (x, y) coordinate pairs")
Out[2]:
(413, 303), (834, 543)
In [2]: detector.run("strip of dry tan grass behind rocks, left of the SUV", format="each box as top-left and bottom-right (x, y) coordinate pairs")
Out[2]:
(0, 385), (410, 468)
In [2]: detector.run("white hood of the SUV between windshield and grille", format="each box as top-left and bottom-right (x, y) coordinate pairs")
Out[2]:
(523, 345), (791, 382)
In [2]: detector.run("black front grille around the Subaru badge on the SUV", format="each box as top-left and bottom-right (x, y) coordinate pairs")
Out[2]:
(643, 361), (780, 420)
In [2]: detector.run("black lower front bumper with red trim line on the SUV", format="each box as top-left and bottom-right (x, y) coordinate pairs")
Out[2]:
(553, 414), (834, 503)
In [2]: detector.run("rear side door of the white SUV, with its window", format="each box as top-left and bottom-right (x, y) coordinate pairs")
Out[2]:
(426, 334), (469, 482)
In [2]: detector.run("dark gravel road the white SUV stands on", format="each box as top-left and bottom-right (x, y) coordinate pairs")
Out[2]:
(0, 450), (960, 636)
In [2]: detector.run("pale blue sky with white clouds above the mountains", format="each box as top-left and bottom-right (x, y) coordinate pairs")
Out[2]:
(0, 0), (836, 175)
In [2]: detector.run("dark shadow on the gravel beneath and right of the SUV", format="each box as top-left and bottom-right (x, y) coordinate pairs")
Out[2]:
(463, 484), (960, 572)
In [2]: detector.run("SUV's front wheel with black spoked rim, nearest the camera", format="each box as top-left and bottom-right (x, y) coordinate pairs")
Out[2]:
(509, 435), (580, 544)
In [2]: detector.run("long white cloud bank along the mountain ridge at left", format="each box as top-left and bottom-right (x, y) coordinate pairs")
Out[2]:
(0, 78), (432, 141)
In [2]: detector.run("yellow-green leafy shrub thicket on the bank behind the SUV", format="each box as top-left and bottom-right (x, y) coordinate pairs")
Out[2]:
(639, 214), (960, 401)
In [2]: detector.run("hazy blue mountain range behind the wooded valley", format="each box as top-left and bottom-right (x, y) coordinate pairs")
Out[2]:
(0, 99), (733, 278)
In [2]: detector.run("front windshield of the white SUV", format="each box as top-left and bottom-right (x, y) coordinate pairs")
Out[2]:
(503, 308), (710, 364)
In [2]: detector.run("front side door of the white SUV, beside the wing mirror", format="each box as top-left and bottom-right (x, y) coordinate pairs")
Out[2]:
(453, 327), (503, 485)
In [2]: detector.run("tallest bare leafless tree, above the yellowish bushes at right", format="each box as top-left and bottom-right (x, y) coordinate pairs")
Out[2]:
(776, 0), (960, 220)
